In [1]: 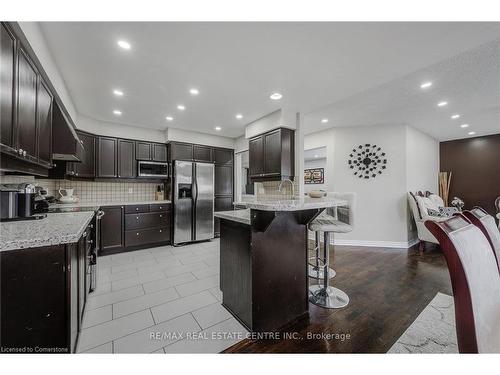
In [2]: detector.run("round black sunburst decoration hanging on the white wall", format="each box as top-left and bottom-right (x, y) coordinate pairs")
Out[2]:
(347, 143), (387, 180)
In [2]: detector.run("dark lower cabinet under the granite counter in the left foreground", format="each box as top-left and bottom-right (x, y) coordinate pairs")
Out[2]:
(0, 222), (91, 353)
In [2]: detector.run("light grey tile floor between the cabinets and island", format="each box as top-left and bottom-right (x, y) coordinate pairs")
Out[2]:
(77, 240), (247, 353)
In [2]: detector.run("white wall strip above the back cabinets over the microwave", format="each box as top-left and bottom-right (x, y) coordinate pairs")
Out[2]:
(76, 115), (167, 142)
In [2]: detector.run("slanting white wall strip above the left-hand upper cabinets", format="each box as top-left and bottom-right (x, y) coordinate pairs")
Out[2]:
(18, 22), (77, 123)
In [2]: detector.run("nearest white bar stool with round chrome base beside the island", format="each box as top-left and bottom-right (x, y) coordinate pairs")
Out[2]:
(309, 193), (356, 309)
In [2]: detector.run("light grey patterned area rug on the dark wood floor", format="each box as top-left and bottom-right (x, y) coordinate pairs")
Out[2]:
(388, 293), (458, 354)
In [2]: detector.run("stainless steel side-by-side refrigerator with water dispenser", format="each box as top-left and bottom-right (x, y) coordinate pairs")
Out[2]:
(173, 160), (214, 244)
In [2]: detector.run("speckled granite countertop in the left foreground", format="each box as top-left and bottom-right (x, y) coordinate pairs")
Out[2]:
(0, 211), (95, 252)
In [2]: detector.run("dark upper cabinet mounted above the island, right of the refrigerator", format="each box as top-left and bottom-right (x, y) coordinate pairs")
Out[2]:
(249, 128), (295, 181)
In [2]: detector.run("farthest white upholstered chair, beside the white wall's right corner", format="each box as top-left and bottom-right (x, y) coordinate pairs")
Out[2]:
(408, 192), (446, 254)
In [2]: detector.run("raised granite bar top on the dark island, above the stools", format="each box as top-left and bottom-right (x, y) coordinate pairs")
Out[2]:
(234, 196), (347, 211)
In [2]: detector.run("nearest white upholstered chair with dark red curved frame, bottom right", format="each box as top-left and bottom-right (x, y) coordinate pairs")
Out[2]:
(425, 214), (500, 353)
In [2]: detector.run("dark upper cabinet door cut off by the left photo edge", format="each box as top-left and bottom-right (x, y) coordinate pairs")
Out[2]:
(0, 24), (16, 148)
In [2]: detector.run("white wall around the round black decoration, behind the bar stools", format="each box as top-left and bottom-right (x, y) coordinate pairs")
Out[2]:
(304, 125), (439, 247)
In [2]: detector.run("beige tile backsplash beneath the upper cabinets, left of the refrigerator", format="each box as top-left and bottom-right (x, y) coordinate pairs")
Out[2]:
(0, 175), (164, 203)
